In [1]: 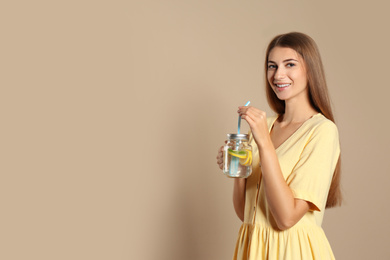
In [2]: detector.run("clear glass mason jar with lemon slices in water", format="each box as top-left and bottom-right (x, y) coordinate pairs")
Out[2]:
(223, 134), (252, 178)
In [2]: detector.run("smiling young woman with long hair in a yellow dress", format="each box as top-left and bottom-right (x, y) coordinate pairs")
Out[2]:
(217, 32), (341, 260)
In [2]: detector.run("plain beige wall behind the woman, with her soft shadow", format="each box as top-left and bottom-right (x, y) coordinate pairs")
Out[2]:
(0, 0), (390, 260)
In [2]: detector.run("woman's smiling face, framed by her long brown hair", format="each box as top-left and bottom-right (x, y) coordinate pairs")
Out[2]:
(267, 47), (308, 101)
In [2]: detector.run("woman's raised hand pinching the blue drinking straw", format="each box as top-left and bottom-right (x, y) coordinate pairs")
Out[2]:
(237, 106), (270, 148)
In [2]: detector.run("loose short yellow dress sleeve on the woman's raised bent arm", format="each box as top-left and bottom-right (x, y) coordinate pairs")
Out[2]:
(286, 120), (340, 211)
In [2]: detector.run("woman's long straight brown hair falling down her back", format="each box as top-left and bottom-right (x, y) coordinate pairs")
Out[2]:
(264, 32), (342, 208)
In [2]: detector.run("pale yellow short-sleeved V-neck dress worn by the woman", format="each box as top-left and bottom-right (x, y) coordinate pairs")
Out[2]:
(233, 113), (340, 260)
